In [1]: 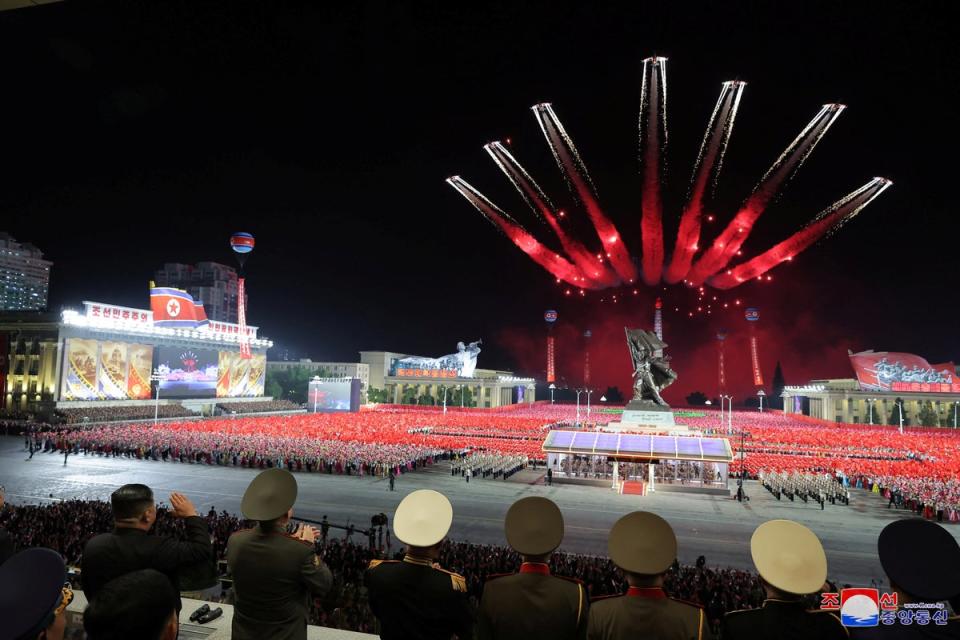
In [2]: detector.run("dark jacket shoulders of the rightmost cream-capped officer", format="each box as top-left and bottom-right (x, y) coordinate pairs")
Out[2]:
(721, 599), (849, 640)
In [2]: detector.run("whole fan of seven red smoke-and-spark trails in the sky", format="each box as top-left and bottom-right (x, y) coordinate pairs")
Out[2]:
(447, 57), (892, 295)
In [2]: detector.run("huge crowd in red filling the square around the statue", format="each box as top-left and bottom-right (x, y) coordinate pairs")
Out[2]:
(15, 403), (960, 522)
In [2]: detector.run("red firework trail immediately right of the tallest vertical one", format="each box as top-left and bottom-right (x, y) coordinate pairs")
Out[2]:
(663, 80), (747, 284)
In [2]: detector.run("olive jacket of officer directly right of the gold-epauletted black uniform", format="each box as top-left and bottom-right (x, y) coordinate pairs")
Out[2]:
(476, 573), (590, 640)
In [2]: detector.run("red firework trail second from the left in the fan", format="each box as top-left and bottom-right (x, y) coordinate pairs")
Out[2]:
(483, 142), (620, 289)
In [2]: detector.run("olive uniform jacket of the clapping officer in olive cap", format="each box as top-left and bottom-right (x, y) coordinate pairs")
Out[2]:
(227, 527), (333, 640)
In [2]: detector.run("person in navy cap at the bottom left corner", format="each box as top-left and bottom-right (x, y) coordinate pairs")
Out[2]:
(0, 547), (73, 640)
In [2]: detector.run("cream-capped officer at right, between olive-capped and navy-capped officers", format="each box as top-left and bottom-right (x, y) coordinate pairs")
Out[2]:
(721, 520), (848, 640)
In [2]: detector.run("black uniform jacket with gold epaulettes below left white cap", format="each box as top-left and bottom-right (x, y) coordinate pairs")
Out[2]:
(366, 557), (473, 640)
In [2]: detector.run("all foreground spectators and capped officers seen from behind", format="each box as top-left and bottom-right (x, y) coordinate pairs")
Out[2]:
(0, 469), (960, 640)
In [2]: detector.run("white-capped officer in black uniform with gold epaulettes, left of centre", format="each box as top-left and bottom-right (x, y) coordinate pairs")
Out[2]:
(366, 489), (473, 640)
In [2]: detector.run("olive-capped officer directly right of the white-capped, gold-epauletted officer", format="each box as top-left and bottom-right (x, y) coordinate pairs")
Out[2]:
(477, 497), (589, 640)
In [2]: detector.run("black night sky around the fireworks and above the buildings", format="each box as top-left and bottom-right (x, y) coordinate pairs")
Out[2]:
(0, 0), (960, 401)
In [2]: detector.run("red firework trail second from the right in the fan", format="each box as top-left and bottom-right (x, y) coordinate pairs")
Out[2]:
(687, 104), (846, 286)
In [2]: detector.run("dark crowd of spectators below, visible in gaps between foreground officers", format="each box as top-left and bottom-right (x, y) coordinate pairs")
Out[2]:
(0, 492), (788, 632)
